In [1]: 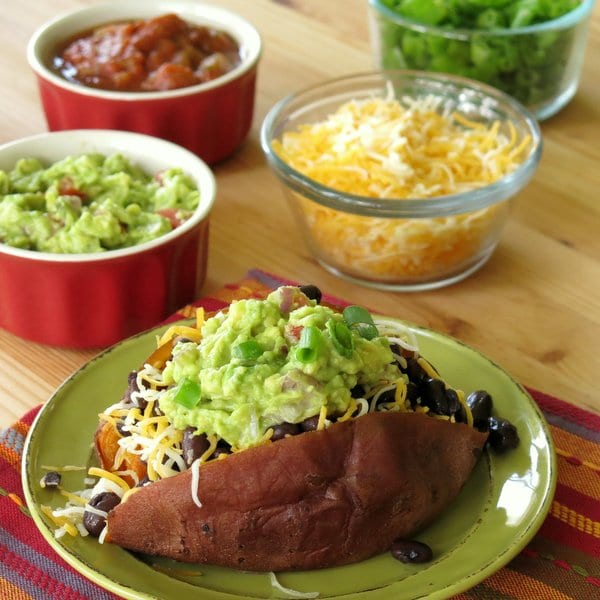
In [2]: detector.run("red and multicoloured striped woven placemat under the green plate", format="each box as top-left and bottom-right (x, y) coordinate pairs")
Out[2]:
(0, 270), (600, 600)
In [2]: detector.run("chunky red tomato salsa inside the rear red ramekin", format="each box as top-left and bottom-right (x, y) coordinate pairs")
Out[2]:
(53, 14), (241, 92)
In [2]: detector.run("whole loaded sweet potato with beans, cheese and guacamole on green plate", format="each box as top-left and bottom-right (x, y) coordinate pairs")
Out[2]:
(43, 286), (518, 571)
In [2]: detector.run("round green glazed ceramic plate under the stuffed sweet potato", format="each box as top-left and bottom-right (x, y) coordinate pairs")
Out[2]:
(23, 316), (556, 600)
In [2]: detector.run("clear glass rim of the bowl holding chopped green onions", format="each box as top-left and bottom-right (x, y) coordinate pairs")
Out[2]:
(369, 0), (596, 40)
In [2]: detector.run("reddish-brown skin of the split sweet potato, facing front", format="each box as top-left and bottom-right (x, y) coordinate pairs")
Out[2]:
(107, 413), (487, 571)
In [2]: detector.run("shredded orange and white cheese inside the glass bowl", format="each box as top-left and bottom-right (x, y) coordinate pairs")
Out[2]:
(274, 90), (531, 282)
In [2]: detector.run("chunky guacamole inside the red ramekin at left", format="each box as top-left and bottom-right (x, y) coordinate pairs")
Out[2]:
(0, 153), (200, 254)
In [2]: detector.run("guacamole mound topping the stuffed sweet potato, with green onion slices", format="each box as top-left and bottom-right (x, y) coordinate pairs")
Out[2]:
(160, 287), (405, 450)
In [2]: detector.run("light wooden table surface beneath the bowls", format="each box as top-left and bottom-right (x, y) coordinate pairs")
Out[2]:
(0, 0), (600, 428)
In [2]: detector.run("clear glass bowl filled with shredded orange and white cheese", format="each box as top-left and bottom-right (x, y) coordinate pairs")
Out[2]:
(261, 71), (542, 291)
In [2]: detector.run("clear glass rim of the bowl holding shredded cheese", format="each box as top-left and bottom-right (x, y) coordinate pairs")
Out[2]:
(260, 70), (543, 219)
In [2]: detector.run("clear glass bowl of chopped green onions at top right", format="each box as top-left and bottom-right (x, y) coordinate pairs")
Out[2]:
(369, 0), (595, 120)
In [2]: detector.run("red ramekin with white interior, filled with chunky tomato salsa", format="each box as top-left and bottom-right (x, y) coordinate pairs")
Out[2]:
(27, 0), (262, 164)
